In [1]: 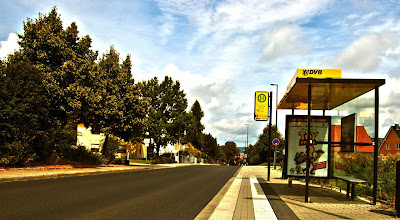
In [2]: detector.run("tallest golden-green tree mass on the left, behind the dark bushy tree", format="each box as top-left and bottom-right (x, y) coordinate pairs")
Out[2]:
(8, 7), (147, 164)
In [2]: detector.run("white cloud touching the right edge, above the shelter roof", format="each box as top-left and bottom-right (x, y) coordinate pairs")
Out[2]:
(328, 32), (400, 72)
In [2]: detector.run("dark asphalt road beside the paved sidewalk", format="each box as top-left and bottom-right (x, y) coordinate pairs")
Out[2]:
(0, 166), (239, 219)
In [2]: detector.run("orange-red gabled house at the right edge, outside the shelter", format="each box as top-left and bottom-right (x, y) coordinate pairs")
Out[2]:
(379, 124), (400, 156)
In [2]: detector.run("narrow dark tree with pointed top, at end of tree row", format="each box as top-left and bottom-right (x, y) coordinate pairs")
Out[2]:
(187, 100), (204, 151)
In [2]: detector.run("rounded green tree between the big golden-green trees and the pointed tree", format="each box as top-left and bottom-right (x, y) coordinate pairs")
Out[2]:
(143, 76), (188, 155)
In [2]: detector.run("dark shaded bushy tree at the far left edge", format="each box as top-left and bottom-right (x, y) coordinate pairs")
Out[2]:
(0, 61), (51, 166)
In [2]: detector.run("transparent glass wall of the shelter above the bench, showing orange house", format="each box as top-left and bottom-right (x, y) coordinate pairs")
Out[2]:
(326, 90), (375, 176)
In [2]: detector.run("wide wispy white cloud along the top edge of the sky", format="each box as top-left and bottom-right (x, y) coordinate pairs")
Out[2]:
(158, 0), (329, 53)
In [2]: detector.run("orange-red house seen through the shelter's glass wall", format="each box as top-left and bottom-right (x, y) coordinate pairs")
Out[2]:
(331, 125), (374, 153)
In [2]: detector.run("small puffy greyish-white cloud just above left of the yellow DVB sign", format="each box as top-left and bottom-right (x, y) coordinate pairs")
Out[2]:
(260, 23), (309, 62)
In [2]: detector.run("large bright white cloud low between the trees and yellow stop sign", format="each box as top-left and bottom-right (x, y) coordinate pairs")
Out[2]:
(152, 64), (258, 144)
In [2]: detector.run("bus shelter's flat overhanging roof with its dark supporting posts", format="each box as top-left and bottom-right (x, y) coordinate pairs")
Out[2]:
(277, 74), (385, 204)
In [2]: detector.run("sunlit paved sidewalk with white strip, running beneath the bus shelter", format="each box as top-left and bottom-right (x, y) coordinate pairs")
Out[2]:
(196, 166), (395, 220)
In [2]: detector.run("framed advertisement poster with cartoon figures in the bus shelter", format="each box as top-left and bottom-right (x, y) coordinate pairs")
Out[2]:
(286, 115), (331, 177)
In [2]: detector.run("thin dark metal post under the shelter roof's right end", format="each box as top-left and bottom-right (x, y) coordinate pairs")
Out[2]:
(372, 87), (379, 205)
